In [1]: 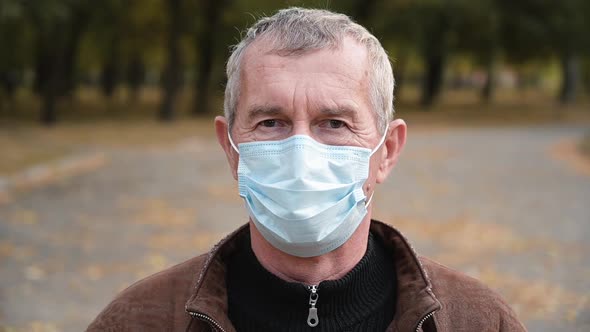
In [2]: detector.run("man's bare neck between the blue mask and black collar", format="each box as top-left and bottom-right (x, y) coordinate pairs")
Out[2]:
(250, 214), (370, 285)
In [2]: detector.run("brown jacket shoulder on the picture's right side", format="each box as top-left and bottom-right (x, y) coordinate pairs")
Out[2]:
(420, 257), (526, 331)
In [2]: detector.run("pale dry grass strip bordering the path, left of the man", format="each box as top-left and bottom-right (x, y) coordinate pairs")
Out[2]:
(0, 120), (214, 176)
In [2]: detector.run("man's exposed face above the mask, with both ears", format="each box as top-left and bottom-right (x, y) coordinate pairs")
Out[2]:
(216, 38), (405, 201)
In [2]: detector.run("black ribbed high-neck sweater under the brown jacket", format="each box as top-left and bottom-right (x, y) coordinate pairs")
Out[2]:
(227, 234), (397, 332)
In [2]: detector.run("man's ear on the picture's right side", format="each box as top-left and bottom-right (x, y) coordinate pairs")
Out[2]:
(375, 119), (407, 183)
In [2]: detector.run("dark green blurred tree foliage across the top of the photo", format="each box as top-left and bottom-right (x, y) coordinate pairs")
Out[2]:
(0, 0), (590, 122)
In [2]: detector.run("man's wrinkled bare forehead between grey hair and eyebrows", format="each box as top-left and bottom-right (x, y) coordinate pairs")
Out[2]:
(238, 37), (369, 113)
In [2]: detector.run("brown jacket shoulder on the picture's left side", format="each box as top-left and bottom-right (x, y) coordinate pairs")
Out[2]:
(87, 254), (206, 331)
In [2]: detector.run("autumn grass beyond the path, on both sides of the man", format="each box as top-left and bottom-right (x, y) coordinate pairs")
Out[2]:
(0, 87), (590, 176)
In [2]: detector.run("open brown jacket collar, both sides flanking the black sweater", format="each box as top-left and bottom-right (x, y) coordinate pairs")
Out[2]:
(185, 220), (441, 332)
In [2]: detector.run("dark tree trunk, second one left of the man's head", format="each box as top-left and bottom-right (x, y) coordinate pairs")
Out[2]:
(158, 0), (182, 121)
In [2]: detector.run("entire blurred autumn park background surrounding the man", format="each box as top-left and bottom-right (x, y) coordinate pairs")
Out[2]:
(0, 0), (590, 331)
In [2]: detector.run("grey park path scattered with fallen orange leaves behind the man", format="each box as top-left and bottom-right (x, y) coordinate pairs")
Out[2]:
(0, 124), (590, 331)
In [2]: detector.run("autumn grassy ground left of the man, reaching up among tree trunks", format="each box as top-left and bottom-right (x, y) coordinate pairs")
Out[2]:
(0, 89), (219, 176)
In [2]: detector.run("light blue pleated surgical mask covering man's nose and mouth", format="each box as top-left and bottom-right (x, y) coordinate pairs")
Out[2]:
(228, 130), (387, 257)
